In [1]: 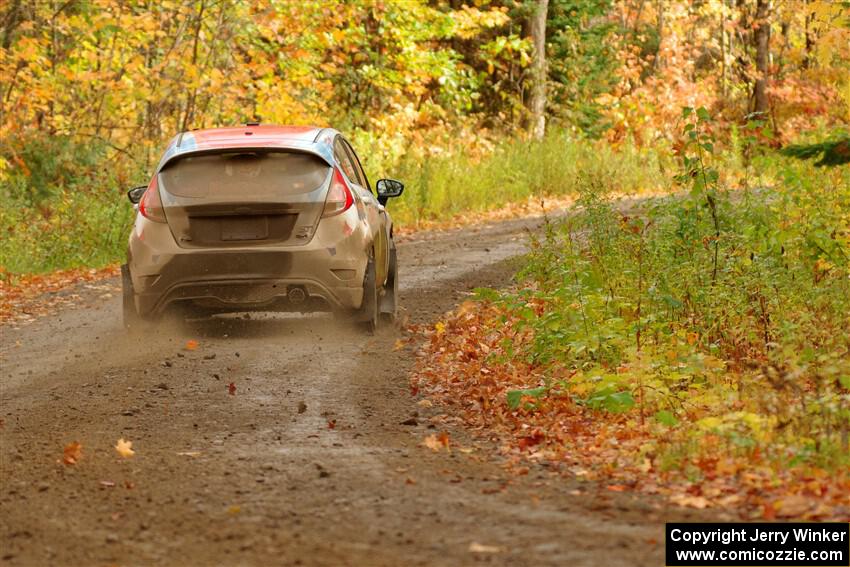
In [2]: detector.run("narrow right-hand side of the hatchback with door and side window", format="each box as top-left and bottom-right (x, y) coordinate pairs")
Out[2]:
(334, 136), (389, 284)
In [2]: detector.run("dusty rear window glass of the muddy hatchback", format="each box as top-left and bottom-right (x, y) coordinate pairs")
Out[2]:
(159, 152), (330, 199)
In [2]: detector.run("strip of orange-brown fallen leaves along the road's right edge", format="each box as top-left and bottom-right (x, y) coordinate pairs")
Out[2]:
(411, 302), (850, 521)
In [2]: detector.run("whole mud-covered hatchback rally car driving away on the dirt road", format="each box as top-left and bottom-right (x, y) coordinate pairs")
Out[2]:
(122, 124), (404, 330)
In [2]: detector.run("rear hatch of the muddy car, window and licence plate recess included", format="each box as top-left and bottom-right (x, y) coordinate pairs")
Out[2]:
(158, 149), (331, 248)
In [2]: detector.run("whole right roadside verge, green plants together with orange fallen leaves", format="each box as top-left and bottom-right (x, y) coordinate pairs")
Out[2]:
(414, 121), (850, 521)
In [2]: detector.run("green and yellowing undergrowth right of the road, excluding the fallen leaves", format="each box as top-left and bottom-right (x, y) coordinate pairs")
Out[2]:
(486, 109), (850, 467)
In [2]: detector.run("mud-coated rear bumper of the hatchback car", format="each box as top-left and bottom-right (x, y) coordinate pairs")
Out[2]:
(128, 209), (371, 316)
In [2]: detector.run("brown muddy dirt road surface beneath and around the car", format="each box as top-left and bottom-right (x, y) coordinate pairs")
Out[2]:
(0, 220), (696, 567)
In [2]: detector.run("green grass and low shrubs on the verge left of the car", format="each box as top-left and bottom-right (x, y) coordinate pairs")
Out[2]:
(0, 136), (145, 274)
